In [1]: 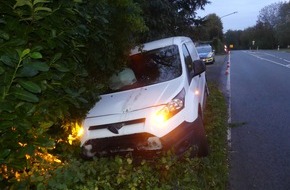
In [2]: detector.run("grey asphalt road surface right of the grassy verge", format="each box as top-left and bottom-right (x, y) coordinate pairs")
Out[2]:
(208, 51), (290, 190)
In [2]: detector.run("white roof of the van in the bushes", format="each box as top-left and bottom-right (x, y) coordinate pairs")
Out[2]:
(131, 36), (191, 55)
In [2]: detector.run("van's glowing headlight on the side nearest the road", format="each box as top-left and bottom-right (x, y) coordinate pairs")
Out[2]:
(154, 89), (185, 125)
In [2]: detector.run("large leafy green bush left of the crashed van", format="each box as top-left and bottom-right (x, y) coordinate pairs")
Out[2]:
(0, 0), (146, 189)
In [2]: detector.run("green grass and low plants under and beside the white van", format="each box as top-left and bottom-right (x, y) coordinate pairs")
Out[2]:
(15, 84), (229, 190)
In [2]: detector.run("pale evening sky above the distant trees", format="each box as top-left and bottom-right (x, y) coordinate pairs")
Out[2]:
(197, 0), (287, 32)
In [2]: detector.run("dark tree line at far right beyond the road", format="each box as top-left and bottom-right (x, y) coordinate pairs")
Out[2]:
(225, 2), (290, 49)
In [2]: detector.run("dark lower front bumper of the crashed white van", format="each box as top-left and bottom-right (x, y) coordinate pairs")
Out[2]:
(82, 120), (198, 157)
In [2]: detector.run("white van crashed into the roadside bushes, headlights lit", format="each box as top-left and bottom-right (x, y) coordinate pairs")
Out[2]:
(81, 37), (208, 157)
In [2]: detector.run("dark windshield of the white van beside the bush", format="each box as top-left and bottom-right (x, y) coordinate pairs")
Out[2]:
(110, 45), (182, 91)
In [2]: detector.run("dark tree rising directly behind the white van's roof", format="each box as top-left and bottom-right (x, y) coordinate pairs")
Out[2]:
(135, 0), (208, 42)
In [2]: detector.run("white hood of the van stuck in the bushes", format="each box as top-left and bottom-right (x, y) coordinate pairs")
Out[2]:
(87, 77), (182, 118)
